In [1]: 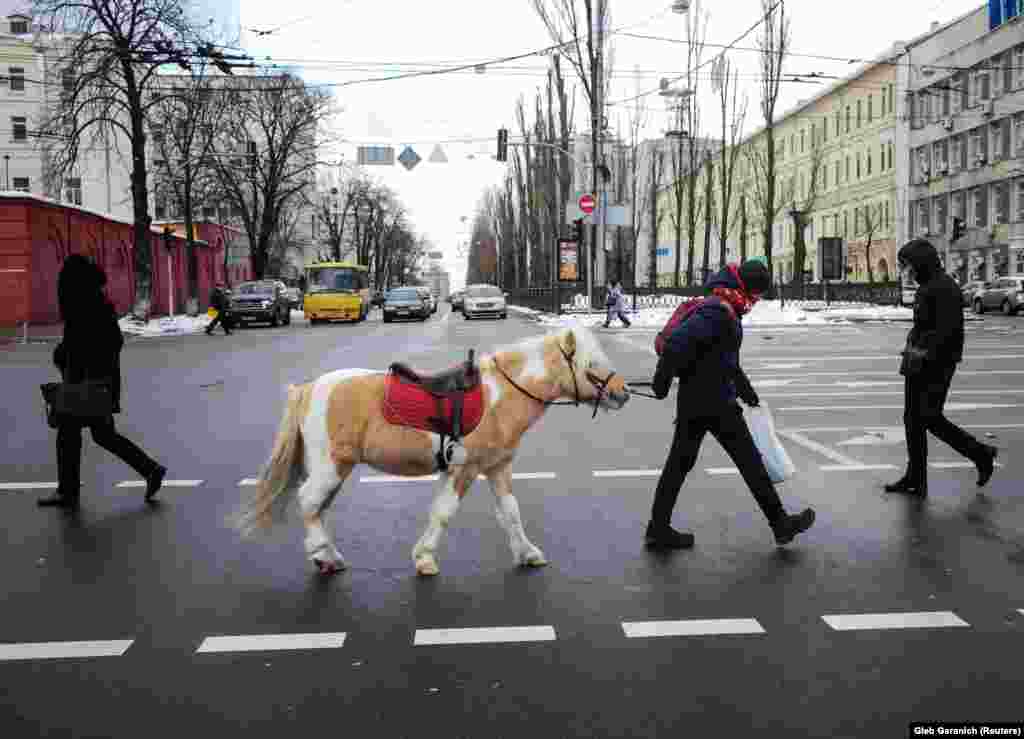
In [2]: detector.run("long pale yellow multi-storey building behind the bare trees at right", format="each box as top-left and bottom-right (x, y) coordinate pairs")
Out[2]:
(658, 47), (902, 281)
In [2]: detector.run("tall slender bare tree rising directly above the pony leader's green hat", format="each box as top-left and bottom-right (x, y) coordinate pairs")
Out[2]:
(752, 0), (791, 273)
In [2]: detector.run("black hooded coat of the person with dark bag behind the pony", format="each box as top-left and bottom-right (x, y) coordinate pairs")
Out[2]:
(53, 254), (124, 412)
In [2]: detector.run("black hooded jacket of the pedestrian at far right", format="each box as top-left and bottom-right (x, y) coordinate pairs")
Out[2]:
(898, 240), (964, 366)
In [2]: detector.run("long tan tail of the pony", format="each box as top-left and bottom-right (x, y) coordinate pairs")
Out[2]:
(234, 383), (313, 535)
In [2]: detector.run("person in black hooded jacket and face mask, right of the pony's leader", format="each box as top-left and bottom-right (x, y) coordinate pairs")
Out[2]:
(885, 238), (997, 497)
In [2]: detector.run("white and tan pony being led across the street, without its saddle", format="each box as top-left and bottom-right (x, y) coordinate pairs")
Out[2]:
(237, 328), (630, 575)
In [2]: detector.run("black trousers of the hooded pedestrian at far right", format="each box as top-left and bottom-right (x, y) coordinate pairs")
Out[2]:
(903, 364), (984, 482)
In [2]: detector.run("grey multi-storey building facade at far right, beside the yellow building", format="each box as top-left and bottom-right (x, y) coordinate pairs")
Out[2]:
(900, 0), (1024, 284)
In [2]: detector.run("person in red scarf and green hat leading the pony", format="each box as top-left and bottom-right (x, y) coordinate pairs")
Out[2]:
(645, 260), (814, 549)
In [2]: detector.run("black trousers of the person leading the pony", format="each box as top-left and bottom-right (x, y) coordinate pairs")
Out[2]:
(650, 402), (785, 525)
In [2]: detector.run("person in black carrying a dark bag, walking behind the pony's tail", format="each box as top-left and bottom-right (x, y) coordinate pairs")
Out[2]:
(39, 254), (167, 509)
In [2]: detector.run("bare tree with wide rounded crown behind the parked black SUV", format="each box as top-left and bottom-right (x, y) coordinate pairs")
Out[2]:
(216, 75), (332, 278)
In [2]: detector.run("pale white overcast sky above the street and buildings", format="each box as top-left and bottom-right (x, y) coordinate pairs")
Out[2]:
(242, 0), (981, 284)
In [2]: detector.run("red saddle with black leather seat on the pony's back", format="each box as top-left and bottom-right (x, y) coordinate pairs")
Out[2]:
(383, 351), (483, 439)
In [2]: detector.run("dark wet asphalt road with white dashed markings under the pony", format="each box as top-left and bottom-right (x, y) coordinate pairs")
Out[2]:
(0, 306), (1024, 739)
